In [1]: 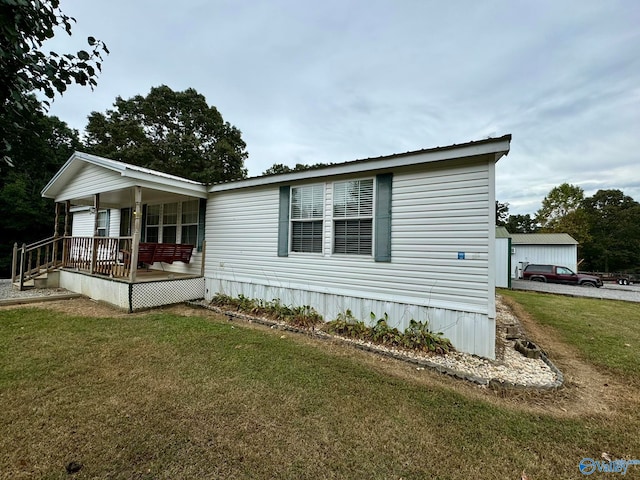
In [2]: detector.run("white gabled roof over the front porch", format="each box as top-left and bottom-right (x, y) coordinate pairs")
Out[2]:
(42, 152), (207, 207)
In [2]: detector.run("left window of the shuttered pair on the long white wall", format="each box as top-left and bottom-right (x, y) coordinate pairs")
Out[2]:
(291, 185), (324, 253)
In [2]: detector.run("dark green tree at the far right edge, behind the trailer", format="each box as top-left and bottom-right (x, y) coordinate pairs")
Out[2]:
(583, 190), (640, 272)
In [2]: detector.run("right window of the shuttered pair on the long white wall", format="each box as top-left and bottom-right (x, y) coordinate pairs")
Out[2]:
(333, 178), (373, 255)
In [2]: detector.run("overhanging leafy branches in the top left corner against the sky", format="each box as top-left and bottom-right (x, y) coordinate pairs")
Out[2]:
(0, 0), (109, 165)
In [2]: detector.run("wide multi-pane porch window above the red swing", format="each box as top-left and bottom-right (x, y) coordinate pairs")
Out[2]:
(145, 199), (200, 245)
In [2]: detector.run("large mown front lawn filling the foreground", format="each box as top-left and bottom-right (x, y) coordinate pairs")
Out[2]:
(0, 299), (640, 480)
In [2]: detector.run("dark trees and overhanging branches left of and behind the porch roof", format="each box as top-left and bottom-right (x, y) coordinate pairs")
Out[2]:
(0, 0), (248, 277)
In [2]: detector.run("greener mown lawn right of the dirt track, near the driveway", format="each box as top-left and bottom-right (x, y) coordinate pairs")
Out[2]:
(501, 290), (640, 382)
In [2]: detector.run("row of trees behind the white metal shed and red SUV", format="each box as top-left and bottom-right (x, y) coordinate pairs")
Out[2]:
(496, 183), (640, 273)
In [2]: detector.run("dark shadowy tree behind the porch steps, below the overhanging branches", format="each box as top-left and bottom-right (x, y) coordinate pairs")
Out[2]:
(0, 97), (80, 278)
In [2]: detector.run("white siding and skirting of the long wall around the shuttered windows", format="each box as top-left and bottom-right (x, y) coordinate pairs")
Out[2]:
(205, 157), (495, 357)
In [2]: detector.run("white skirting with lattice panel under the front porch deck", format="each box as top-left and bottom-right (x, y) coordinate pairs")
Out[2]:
(60, 270), (204, 312)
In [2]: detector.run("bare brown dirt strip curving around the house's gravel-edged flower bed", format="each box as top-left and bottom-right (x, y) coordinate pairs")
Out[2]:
(0, 297), (640, 417)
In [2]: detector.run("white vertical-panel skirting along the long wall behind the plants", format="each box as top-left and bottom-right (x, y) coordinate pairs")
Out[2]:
(204, 278), (496, 359)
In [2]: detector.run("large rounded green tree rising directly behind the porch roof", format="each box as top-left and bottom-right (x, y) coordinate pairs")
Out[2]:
(86, 85), (248, 183)
